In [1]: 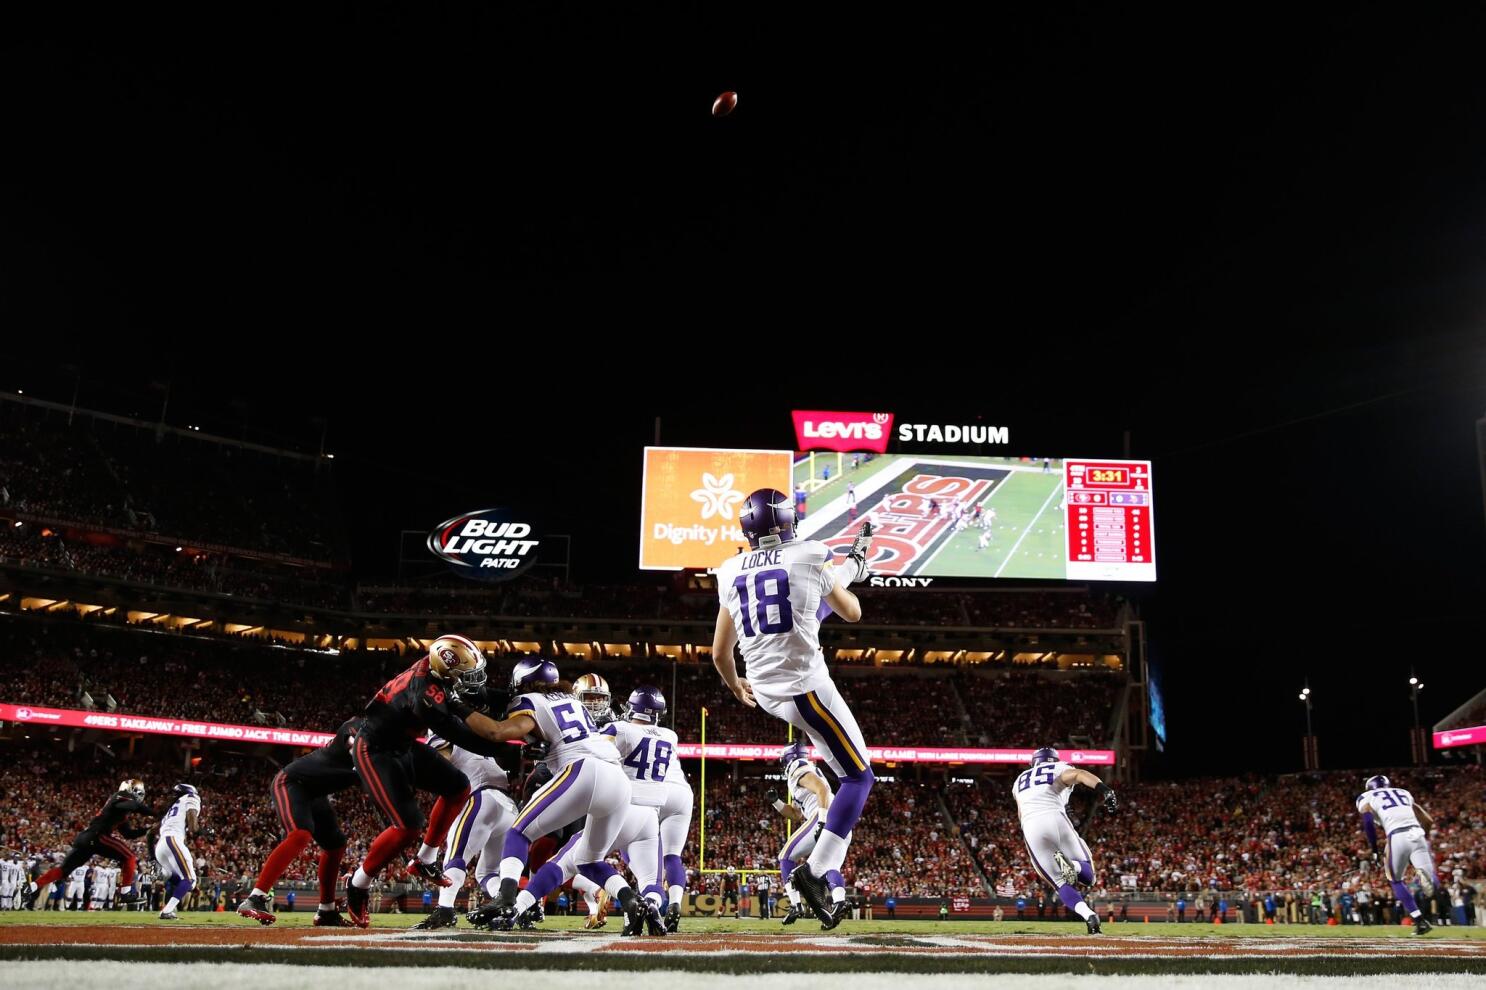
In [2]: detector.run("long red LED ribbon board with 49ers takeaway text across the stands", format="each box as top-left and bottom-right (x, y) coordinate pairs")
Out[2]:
(0, 702), (1115, 766)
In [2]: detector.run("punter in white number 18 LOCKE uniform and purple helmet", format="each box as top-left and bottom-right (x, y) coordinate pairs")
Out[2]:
(712, 488), (874, 923)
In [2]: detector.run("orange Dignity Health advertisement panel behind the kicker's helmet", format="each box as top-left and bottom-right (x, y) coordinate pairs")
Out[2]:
(640, 447), (795, 571)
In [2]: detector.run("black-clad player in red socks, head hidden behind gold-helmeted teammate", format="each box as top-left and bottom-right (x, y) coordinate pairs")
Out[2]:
(238, 716), (361, 928)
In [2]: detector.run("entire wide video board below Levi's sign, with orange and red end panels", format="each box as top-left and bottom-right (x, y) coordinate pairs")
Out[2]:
(640, 449), (1156, 581)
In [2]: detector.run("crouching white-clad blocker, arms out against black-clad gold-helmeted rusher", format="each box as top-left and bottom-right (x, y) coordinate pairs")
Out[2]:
(457, 659), (664, 932)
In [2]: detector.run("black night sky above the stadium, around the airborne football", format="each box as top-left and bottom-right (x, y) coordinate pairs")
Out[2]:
(0, 3), (1486, 770)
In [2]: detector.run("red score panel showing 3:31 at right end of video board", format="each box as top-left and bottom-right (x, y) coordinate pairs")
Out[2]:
(1062, 461), (1156, 581)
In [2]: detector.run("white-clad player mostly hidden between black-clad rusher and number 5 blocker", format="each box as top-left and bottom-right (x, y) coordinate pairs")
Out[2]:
(413, 725), (516, 931)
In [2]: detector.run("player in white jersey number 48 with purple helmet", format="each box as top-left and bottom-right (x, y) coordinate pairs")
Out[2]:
(605, 684), (692, 934)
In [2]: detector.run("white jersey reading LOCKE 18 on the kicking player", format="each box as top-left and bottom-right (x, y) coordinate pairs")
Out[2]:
(718, 540), (837, 696)
